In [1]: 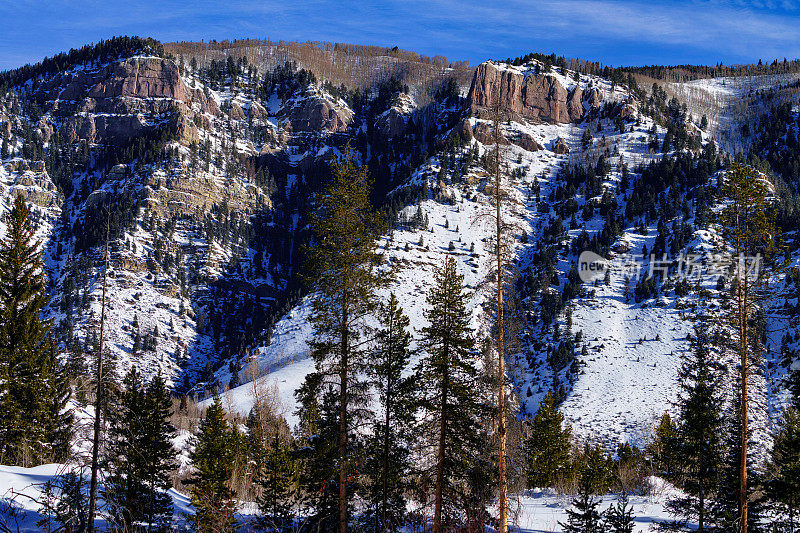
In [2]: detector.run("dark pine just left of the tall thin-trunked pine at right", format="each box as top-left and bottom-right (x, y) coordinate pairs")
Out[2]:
(667, 326), (725, 531)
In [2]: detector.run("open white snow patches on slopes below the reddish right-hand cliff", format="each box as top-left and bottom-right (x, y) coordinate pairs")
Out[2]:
(214, 65), (712, 444)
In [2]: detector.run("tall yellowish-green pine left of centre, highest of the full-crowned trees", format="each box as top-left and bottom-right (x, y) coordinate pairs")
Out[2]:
(308, 150), (385, 533)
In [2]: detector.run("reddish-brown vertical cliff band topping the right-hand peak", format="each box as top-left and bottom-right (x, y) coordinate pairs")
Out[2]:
(467, 62), (599, 124)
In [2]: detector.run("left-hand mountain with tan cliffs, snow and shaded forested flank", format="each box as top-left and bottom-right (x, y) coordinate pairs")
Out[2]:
(0, 47), (460, 389)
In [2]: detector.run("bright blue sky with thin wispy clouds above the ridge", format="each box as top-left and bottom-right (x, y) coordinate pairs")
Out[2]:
(0, 0), (800, 69)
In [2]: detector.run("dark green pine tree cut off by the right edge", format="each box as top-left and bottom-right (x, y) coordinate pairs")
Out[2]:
(767, 406), (800, 531)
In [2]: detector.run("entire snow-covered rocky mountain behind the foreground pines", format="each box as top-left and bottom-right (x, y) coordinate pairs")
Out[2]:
(0, 39), (798, 460)
